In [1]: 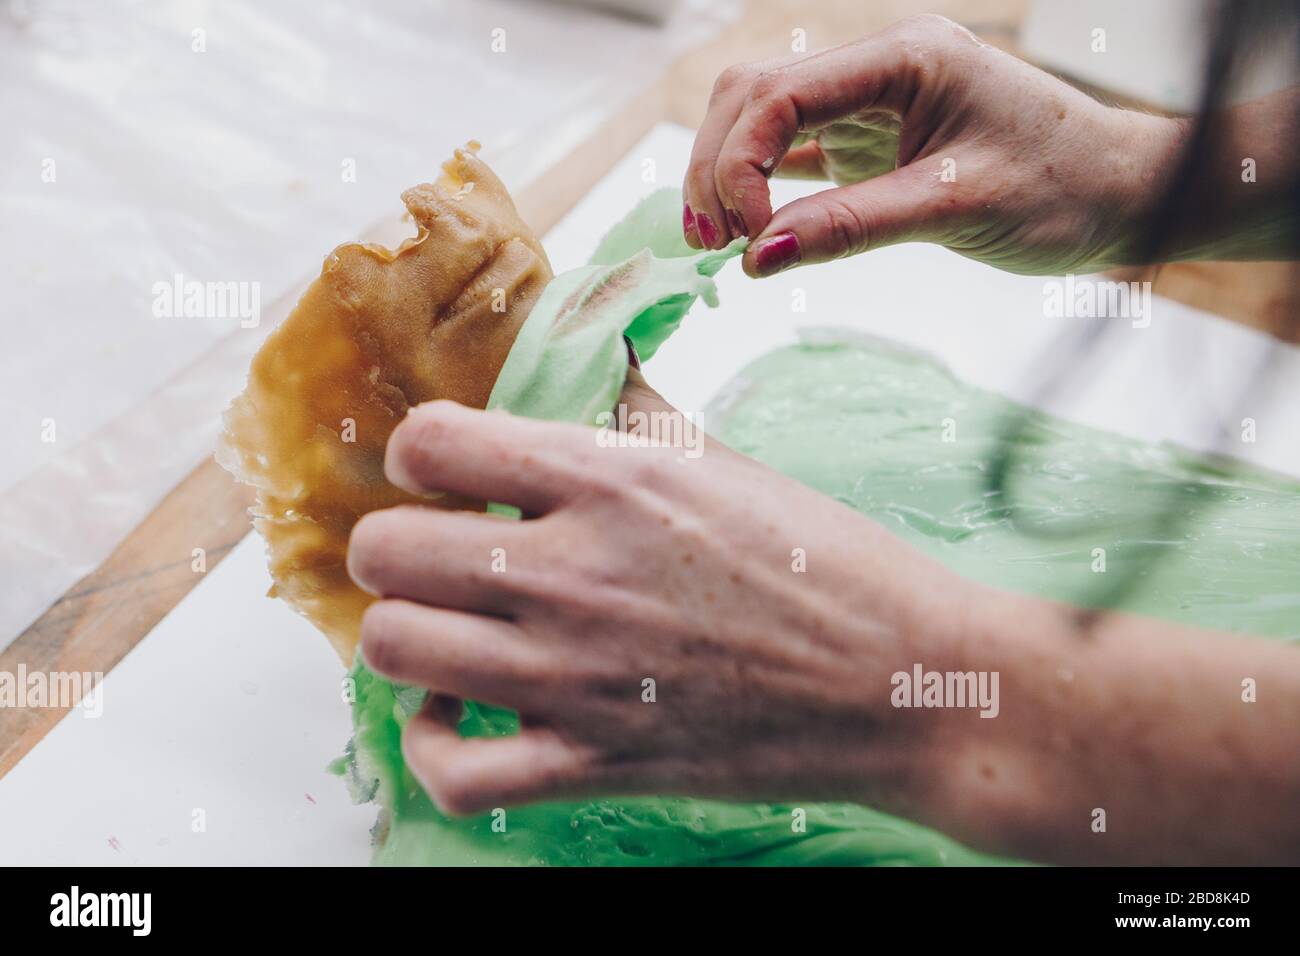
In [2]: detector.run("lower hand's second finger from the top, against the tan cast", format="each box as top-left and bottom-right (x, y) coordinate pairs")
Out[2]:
(347, 505), (530, 617)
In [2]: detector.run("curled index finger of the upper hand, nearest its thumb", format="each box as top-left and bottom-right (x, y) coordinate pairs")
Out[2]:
(714, 31), (920, 247)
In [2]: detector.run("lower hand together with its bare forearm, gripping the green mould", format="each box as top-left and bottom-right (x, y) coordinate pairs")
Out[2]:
(348, 372), (1300, 865)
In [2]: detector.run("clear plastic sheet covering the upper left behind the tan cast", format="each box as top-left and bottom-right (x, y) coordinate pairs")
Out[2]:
(0, 0), (738, 648)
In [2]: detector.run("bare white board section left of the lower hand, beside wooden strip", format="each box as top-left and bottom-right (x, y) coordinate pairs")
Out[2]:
(0, 535), (374, 866)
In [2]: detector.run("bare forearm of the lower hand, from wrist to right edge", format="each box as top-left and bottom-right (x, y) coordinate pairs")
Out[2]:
(924, 593), (1300, 864)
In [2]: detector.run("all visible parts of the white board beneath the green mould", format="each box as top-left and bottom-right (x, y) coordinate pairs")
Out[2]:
(0, 125), (1300, 864)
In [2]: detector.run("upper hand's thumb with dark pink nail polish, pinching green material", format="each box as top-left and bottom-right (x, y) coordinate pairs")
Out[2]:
(741, 157), (957, 278)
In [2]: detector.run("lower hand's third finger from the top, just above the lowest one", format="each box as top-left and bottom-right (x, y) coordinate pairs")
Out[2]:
(361, 600), (549, 709)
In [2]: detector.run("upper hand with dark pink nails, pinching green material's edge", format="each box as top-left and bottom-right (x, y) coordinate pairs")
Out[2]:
(683, 16), (1184, 276)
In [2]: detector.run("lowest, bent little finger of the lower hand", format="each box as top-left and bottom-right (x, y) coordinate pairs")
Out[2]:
(402, 704), (599, 816)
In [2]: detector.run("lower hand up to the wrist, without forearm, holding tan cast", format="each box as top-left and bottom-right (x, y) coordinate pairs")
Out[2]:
(348, 372), (971, 813)
